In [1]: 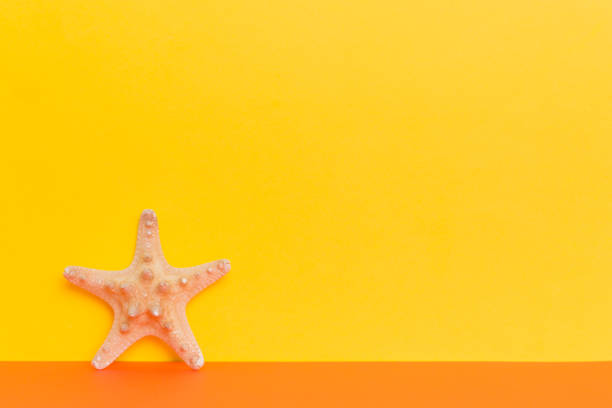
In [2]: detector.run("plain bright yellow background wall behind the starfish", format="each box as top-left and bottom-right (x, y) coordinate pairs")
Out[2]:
(0, 0), (612, 360)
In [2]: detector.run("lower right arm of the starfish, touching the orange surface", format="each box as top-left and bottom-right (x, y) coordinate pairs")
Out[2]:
(159, 305), (204, 370)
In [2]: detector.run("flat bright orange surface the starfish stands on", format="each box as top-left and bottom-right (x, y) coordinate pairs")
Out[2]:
(0, 362), (612, 408)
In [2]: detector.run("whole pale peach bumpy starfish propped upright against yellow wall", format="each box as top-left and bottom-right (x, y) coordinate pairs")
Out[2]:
(64, 210), (230, 370)
